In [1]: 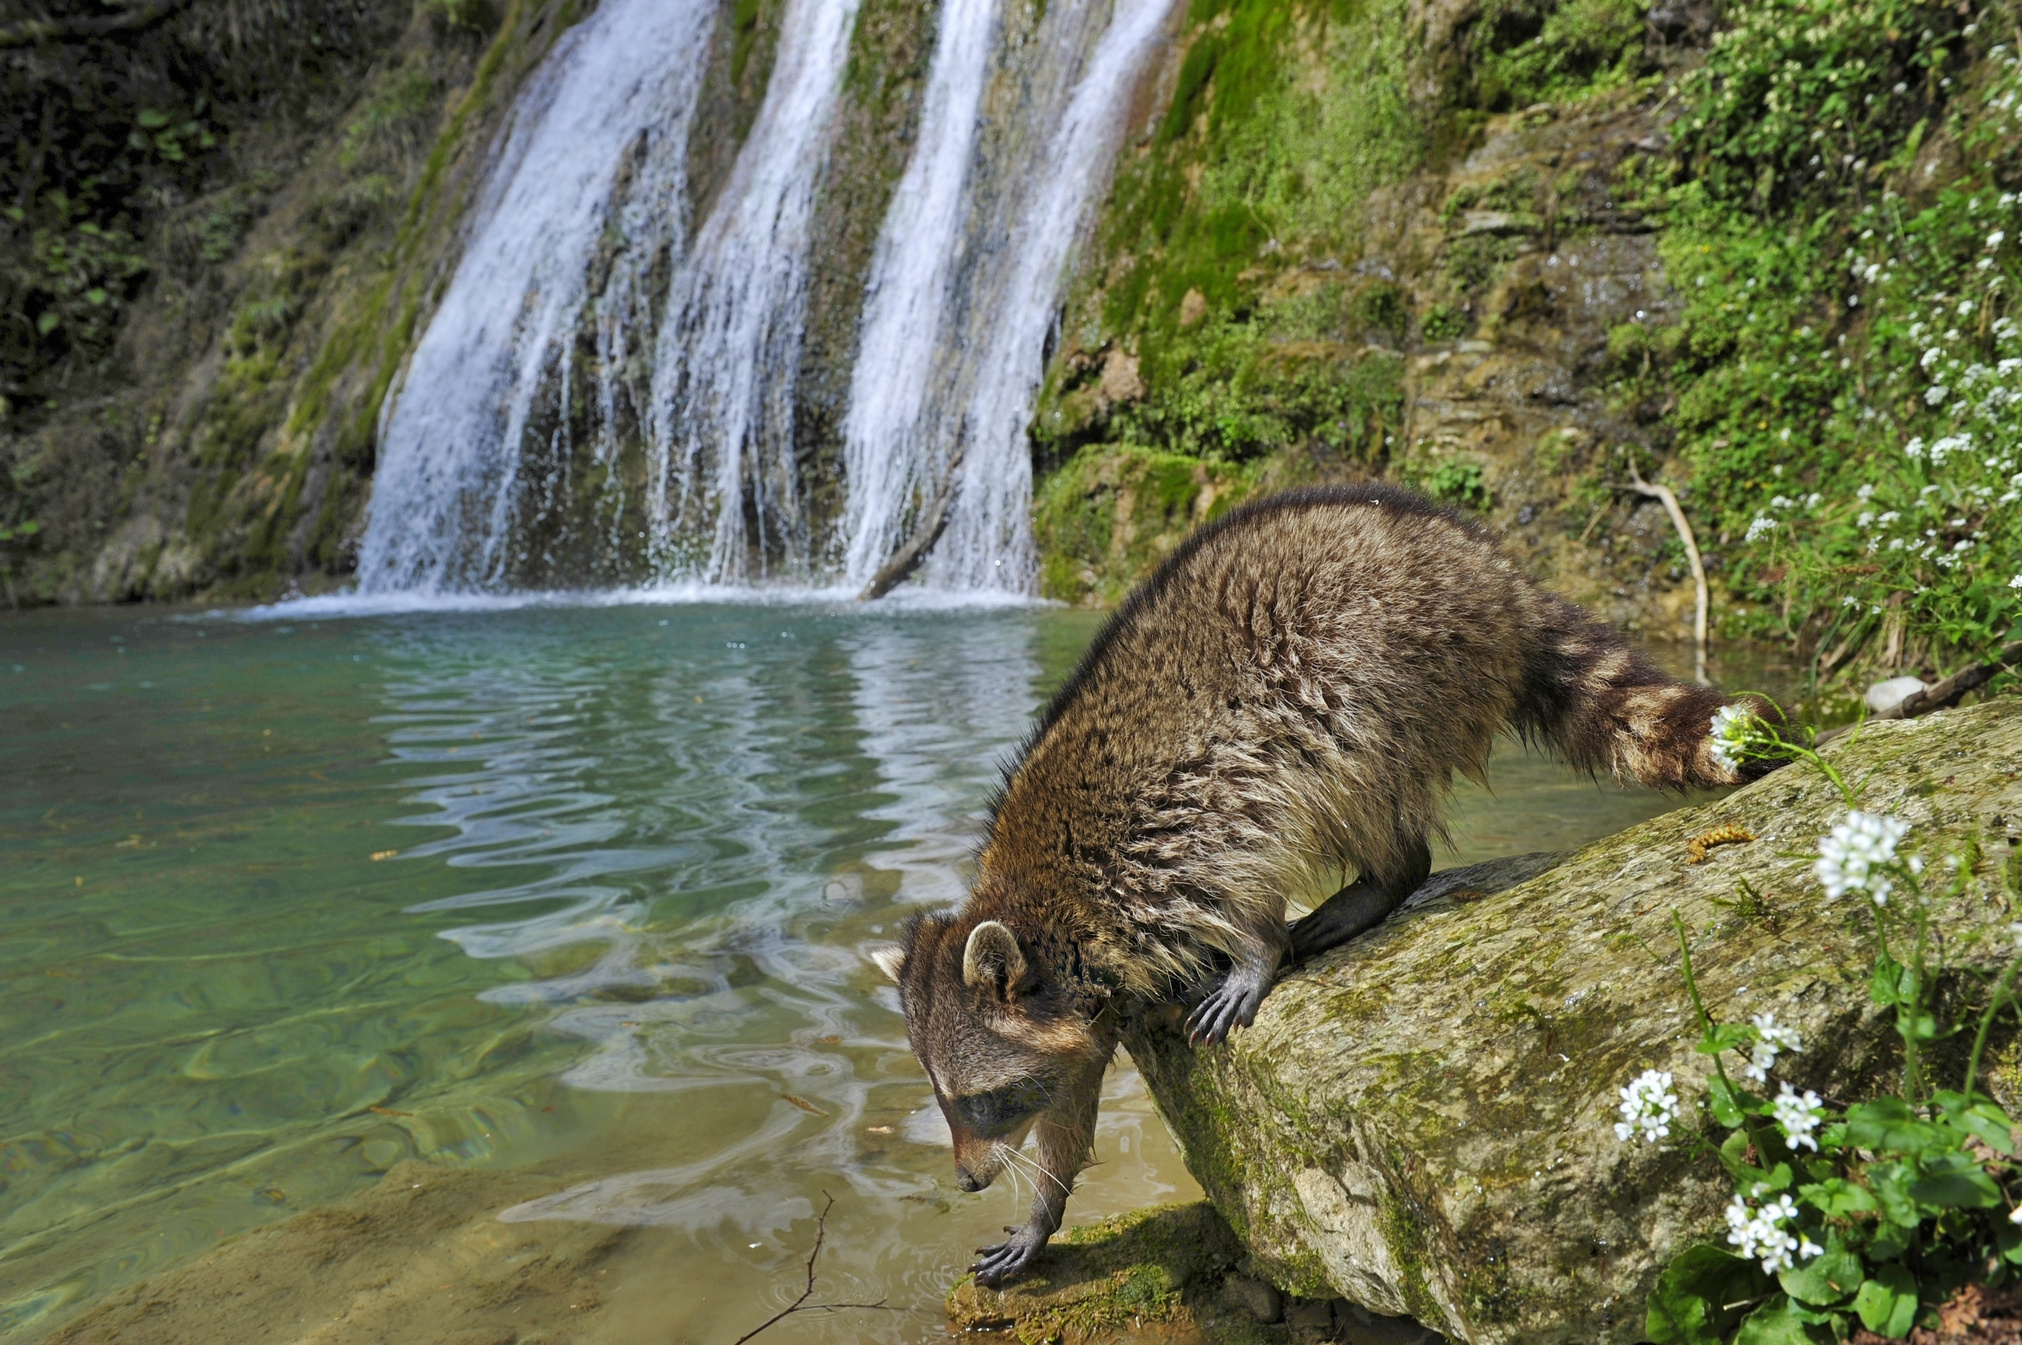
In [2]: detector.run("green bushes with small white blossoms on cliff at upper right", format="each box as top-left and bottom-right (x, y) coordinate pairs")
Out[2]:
(1633, 0), (2022, 671)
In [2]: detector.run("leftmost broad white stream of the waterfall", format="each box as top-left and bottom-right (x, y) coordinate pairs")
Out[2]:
(358, 0), (716, 591)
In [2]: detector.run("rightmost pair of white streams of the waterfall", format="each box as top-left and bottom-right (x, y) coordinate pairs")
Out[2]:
(847, 0), (1173, 593)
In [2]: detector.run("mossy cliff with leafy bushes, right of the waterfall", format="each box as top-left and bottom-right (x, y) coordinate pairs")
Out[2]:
(1033, 0), (2022, 691)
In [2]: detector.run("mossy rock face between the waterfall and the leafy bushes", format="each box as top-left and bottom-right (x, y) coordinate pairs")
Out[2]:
(1035, 2), (1711, 637)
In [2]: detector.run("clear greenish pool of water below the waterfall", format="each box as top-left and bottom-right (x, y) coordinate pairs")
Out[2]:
(0, 603), (1738, 1345)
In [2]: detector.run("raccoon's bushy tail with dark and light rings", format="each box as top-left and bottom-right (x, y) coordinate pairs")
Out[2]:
(1514, 595), (1775, 789)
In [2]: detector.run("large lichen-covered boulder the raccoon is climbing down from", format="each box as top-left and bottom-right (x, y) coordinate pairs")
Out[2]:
(1126, 700), (2022, 1345)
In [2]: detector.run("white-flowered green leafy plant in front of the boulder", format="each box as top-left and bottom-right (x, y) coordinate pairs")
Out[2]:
(1616, 708), (2022, 1345)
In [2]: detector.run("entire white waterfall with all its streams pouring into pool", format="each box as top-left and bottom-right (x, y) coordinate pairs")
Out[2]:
(360, 0), (1175, 593)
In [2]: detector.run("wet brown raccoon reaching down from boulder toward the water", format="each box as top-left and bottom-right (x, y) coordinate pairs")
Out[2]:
(871, 485), (1771, 1284)
